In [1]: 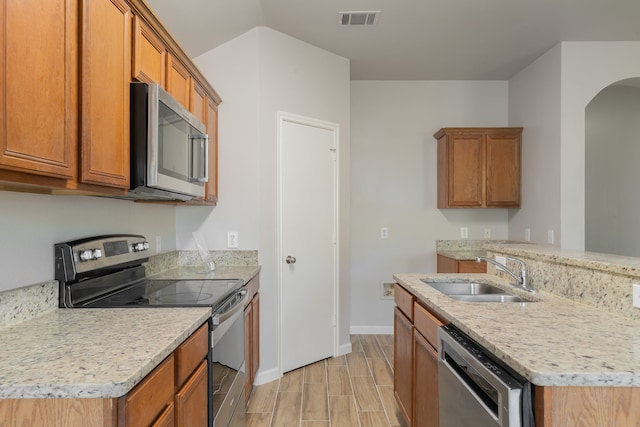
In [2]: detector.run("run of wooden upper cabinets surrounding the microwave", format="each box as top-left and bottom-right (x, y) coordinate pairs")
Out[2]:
(0, 0), (221, 205)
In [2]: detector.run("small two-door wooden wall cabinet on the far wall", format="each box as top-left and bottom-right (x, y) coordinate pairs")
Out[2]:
(434, 128), (522, 209)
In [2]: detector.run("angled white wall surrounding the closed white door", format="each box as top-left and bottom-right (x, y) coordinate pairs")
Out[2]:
(184, 27), (350, 382)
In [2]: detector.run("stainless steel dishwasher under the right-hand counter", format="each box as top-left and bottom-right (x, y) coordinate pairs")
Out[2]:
(438, 325), (535, 427)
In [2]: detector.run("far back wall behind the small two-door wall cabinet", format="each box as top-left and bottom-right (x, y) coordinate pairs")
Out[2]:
(351, 81), (508, 333)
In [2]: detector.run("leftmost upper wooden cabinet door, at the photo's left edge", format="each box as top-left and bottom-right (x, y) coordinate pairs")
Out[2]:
(0, 0), (78, 179)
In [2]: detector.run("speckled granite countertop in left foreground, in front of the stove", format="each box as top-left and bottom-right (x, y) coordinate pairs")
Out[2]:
(0, 307), (211, 399)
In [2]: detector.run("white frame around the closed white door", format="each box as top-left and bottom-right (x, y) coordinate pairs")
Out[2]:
(276, 111), (341, 377)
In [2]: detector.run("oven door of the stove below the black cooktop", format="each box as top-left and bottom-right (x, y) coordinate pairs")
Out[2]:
(211, 290), (247, 427)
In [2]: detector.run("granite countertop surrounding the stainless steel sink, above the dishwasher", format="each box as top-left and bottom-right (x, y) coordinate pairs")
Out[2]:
(394, 274), (640, 387)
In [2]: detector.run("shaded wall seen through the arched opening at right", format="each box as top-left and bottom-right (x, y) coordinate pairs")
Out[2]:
(585, 85), (640, 257)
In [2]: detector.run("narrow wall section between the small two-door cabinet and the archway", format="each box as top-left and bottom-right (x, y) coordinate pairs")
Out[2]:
(509, 45), (561, 245)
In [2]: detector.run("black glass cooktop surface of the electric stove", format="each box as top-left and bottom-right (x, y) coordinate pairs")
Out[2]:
(79, 279), (243, 308)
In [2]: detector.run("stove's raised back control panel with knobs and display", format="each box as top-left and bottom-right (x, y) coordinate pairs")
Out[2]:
(54, 234), (150, 282)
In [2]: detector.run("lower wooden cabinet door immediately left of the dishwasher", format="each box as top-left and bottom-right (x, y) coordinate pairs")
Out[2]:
(412, 331), (439, 427)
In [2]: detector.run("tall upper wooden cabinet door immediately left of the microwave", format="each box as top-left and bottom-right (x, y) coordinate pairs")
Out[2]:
(81, 0), (131, 188)
